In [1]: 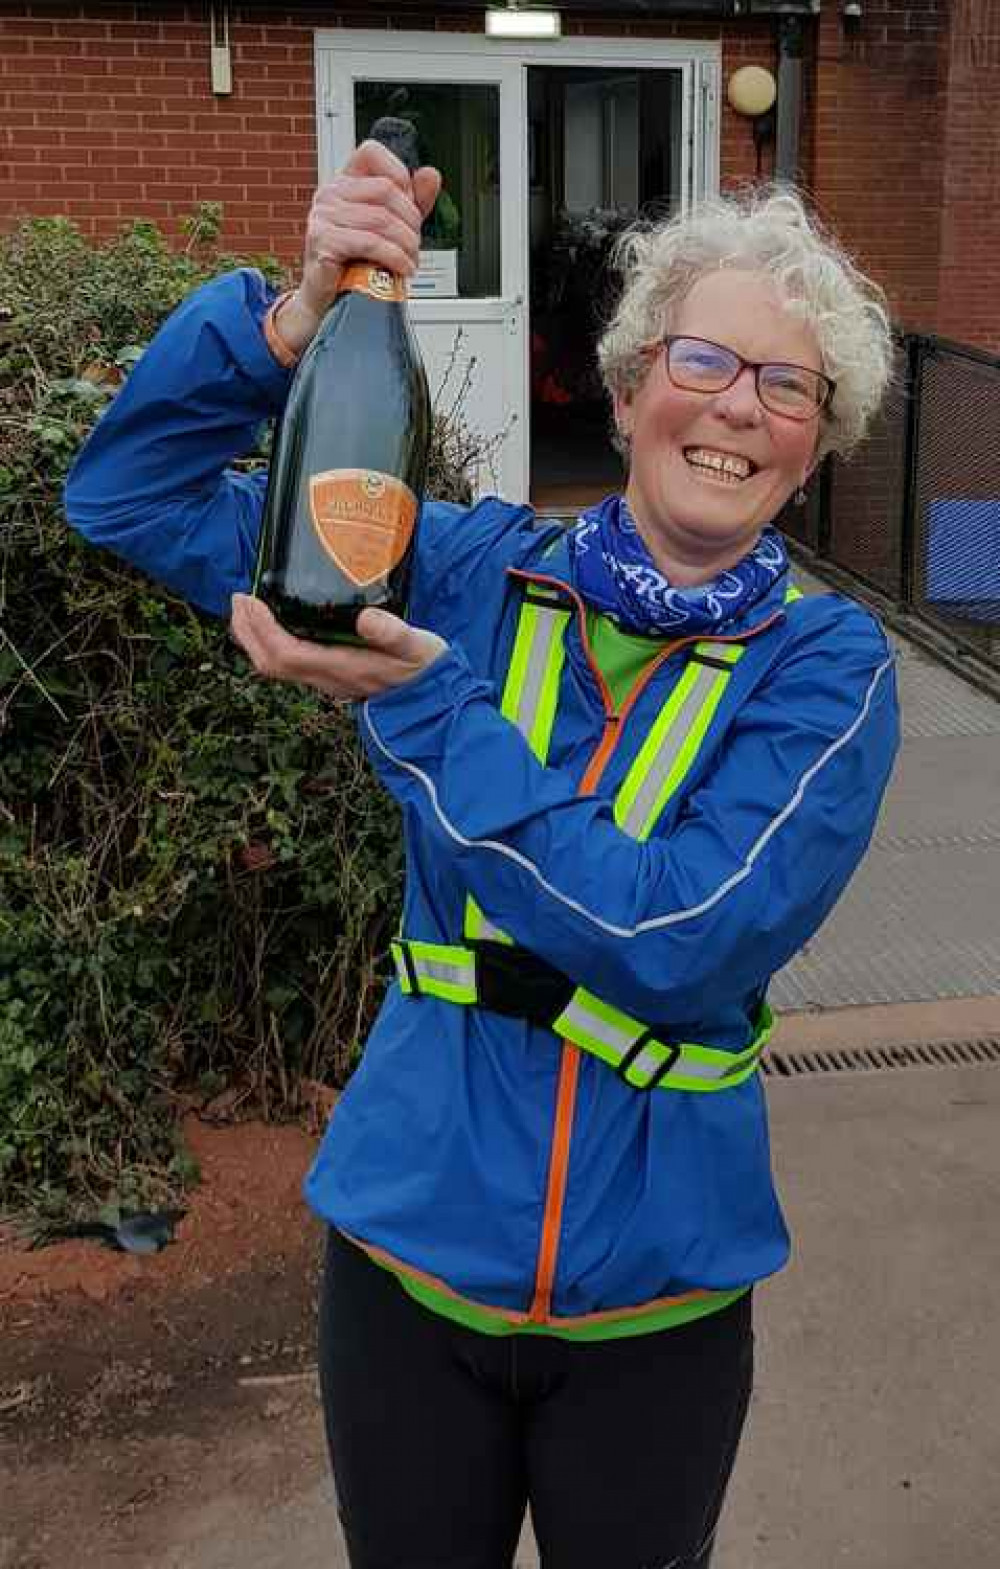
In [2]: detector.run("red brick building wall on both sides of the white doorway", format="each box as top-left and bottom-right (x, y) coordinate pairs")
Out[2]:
(0, 0), (1000, 347)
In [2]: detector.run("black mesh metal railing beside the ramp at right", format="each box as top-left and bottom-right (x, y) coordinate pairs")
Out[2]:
(779, 333), (1000, 668)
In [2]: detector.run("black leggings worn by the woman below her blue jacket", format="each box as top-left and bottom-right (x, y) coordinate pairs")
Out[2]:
(320, 1232), (754, 1569)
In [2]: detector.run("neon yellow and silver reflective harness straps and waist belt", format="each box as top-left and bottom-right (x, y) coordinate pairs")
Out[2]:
(392, 584), (801, 1090)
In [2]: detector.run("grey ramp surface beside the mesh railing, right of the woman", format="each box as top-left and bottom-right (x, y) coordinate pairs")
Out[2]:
(771, 570), (1000, 1012)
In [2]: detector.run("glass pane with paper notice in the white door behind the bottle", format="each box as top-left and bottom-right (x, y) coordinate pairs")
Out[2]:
(355, 82), (501, 300)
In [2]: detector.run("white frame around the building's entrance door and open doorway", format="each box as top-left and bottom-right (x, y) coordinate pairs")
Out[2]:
(314, 27), (722, 501)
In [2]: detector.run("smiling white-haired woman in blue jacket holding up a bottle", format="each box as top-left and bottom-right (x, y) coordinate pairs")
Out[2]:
(66, 143), (896, 1569)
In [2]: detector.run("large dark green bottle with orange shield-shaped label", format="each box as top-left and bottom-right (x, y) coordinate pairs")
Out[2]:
(253, 121), (430, 642)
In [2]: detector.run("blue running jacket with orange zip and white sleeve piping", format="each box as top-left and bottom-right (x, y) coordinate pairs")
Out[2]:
(66, 270), (898, 1332)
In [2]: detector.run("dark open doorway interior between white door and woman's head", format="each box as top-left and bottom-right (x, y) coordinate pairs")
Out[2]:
(527, 66), (683, 513)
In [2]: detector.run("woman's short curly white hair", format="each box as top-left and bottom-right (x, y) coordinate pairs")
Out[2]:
(598, 187), (893, 457)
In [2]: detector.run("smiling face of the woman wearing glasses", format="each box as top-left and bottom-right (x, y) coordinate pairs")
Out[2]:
(615, 268), (823, 582)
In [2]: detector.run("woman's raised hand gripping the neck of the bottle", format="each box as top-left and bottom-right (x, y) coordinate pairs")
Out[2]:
(281, 141), (441, 351)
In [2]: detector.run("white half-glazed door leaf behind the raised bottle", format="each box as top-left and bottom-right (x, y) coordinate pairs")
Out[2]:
(317, 42), (529, 501)
